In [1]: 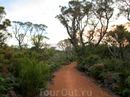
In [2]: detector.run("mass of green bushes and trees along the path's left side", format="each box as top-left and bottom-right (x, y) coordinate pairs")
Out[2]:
(0, 7), (70, 97)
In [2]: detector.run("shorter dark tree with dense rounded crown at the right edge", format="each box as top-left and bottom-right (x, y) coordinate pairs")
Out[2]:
(107, 25), (130, 60)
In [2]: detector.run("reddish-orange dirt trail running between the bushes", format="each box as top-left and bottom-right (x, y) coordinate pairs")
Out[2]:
(46, 62), (116, 97)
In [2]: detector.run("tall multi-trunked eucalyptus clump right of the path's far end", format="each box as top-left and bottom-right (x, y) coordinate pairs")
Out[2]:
(56, 0), (114, 52)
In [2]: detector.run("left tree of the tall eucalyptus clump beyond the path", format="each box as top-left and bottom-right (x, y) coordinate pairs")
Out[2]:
(56, 0), (95, 48)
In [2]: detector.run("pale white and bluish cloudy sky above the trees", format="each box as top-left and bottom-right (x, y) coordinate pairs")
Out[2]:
(0, 0), (127, 45)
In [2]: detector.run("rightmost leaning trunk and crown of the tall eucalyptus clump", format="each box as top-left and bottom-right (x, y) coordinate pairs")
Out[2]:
(92, 0), (114, 48)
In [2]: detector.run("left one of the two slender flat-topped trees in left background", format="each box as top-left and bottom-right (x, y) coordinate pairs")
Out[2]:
(13, 21), (32, 50)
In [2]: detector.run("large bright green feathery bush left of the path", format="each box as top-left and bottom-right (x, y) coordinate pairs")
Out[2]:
(11, 58), (49, 97)
